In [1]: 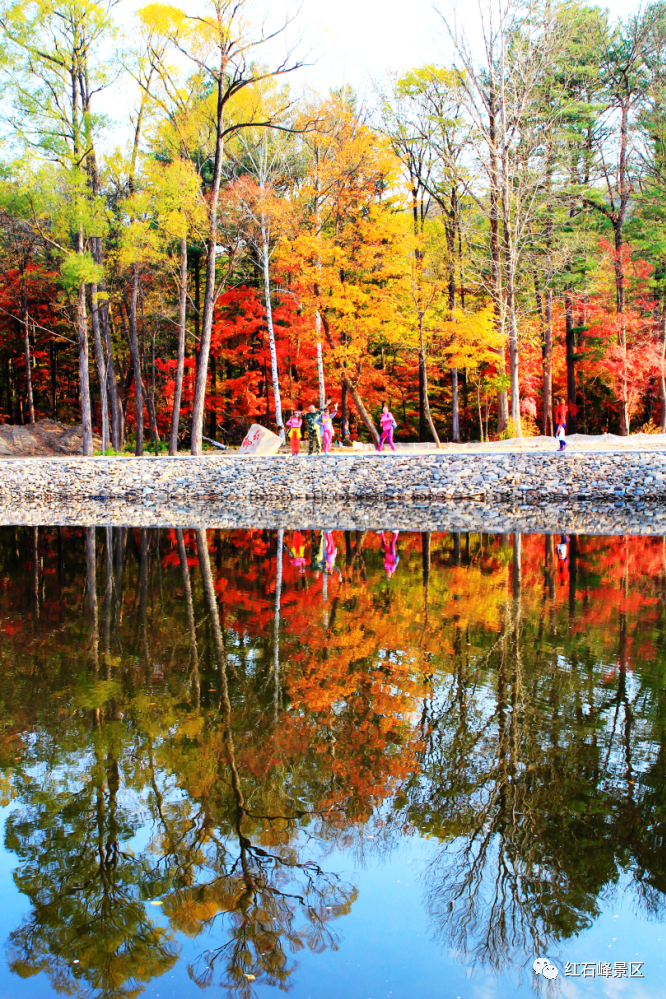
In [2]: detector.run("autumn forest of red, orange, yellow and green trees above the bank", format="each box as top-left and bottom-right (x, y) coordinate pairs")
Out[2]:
(0, 0), (666, 454)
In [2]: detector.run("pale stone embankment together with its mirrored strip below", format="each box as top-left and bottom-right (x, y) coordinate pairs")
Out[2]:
(0, 449), (666, 535)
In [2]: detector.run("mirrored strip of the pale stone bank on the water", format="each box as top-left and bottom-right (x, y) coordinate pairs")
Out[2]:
(0, 493), (666, 536)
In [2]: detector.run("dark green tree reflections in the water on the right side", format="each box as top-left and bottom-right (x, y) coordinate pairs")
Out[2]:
(409, 539), (664, 970)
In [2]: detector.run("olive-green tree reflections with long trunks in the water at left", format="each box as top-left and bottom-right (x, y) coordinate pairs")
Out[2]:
(0, 531), (355, 996)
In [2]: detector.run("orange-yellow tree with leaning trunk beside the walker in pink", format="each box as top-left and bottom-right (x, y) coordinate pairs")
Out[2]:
(280, 100), (411, 444)
